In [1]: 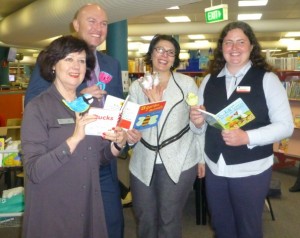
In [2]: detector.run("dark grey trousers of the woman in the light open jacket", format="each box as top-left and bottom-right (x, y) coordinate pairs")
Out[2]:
(130, 165), (197, 238)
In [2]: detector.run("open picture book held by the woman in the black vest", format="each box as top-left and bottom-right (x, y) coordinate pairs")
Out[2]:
(198, 98), (255, 130)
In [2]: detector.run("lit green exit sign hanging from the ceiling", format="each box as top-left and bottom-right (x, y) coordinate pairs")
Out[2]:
(205, 4), (228, 23)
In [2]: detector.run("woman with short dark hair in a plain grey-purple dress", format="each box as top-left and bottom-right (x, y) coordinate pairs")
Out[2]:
(21, 36), (126, 238)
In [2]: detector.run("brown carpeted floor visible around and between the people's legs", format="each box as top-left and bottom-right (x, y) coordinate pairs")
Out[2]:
(0, 161), (300, 238)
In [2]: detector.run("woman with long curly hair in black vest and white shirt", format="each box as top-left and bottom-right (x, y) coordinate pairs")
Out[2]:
(190, 21), (294, 238)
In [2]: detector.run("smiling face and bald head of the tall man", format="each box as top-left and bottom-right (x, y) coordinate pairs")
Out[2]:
(73, 5), (108, 49)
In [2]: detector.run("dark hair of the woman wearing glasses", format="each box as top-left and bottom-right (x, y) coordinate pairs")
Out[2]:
(144, 34), (180, 71)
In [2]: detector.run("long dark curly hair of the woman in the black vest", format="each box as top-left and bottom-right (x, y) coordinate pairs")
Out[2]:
(210, 21), (272, 75)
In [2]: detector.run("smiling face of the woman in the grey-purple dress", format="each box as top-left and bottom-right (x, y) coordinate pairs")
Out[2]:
(53, 51), (86, 91)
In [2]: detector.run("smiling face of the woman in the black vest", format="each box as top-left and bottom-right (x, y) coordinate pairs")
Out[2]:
(222, 28), (253, 74)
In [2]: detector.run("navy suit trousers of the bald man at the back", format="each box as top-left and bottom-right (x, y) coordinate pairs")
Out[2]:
(100, 161), (124, 238)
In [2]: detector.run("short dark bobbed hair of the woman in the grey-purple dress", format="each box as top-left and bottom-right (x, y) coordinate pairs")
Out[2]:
(37, 35), (95, 82)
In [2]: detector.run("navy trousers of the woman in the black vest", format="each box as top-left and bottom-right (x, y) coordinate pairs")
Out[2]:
(205, 166), (272, 238)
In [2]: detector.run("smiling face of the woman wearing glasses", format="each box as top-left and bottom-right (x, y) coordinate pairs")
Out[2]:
(151, 40), (175, 73)
